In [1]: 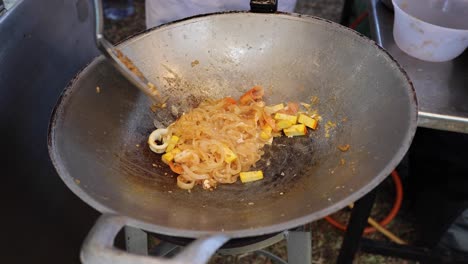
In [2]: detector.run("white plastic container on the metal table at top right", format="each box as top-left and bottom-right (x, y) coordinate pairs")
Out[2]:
(392, 0), (468, 62)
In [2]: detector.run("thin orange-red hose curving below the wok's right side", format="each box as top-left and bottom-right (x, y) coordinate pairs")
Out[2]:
(325, 170), (403, 234)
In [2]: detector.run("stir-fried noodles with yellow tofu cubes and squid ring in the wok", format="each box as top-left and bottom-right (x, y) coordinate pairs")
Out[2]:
(148, 86), (318, 190)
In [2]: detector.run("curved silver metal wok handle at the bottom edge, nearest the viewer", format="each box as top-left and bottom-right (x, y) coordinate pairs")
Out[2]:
(80, 214), (229, 264)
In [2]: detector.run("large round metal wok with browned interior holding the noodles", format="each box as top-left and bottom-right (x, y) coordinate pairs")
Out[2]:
(49, 9), (417, 263)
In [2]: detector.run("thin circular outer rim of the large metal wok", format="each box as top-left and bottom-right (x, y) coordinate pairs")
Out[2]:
(48, 11), (418, 238)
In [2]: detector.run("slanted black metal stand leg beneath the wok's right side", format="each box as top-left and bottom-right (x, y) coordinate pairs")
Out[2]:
(336, 189), (376, 264)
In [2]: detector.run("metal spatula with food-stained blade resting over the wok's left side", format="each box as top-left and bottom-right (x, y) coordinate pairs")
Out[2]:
(94, 0), (164, 105)
